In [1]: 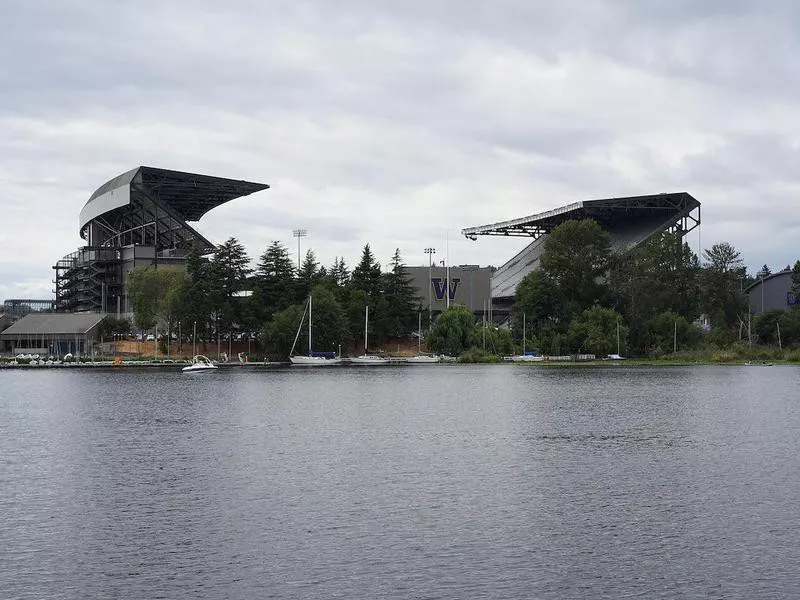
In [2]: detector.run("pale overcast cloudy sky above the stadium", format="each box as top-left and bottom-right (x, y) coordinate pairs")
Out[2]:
(0, 0), (800, 300)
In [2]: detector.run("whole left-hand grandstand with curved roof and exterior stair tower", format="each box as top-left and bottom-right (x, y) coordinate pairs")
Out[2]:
(53, 167), (269, 316)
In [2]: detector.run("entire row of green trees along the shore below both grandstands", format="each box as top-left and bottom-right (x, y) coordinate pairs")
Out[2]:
(122, 219), (800, 359)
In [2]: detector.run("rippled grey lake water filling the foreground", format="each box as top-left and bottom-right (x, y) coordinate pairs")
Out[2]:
(0, 365), (800, 599)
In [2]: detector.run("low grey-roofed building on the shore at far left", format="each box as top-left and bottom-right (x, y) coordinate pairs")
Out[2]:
(0, 312), (105, 356)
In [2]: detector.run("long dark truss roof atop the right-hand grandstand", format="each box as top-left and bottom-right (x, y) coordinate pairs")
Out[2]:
(461, 192), (700, 240)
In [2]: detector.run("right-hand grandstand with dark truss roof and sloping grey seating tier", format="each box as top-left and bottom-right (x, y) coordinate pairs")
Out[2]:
(461, 192), (700, 316)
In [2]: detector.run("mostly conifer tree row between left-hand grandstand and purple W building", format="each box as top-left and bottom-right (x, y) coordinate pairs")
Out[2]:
(122, 238), (421, 358)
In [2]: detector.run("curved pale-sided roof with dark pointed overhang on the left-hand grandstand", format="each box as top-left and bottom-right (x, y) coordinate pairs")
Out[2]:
(79, 167), (269, 251)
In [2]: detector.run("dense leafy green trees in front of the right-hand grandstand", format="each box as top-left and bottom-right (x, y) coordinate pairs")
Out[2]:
(504, 219), (800, 357)
